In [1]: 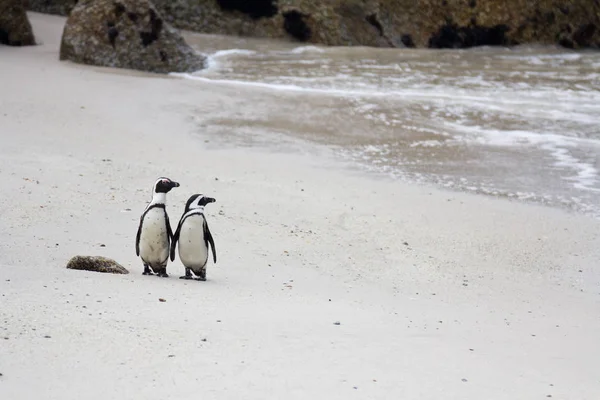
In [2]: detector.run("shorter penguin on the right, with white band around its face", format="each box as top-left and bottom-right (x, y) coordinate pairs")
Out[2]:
(171, 194), (217, 281)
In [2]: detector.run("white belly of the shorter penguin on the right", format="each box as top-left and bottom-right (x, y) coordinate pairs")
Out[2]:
(179, 215), (208, 270)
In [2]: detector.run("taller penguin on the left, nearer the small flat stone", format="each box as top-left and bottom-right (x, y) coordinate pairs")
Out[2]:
(135, 177), (179, 278)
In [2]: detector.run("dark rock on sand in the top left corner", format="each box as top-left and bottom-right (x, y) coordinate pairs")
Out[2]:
(0, 0), (35, 46)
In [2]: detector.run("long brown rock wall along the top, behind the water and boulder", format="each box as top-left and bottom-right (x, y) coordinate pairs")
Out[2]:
(30, 0), (600, 48)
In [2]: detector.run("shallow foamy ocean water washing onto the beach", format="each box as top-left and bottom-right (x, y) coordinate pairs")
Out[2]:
(177, 34), (600, 218)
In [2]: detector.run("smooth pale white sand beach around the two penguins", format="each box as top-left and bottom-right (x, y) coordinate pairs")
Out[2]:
(0, 13), (600, 400)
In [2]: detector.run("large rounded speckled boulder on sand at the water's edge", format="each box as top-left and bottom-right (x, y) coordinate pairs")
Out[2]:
(60, 0), (205, 73)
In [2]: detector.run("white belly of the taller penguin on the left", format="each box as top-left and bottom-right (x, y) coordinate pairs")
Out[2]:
(140, 208), (169, 266)
